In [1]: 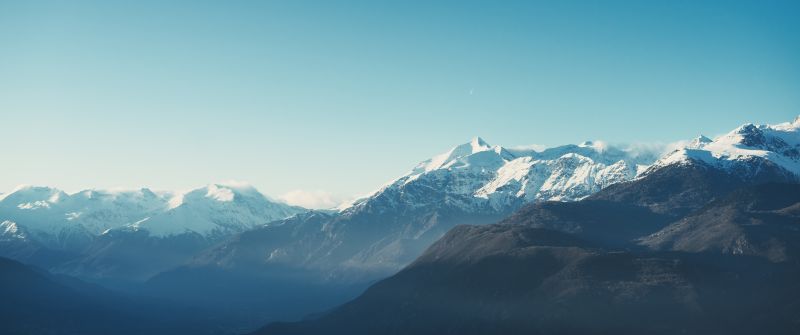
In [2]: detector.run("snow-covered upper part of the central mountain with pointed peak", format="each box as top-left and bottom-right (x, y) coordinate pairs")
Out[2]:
(344, 137), (657, 212)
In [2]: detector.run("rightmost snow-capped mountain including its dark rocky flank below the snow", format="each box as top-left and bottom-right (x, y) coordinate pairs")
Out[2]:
(591, 118), (800, 217)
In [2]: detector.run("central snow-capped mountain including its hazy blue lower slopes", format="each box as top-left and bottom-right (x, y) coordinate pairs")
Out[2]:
(178, 137), (656, 288)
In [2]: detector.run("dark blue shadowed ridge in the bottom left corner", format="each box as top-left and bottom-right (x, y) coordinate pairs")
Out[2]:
(0, 257), (227, 335)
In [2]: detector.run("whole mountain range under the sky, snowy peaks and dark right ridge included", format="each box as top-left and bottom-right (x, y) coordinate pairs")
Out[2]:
(0, 118), (800, 334)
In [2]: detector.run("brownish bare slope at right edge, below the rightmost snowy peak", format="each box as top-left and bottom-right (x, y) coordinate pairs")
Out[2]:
(641, 183), (800, 263)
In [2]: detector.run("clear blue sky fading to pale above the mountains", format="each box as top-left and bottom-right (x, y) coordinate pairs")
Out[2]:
(0, 0), (800, 209)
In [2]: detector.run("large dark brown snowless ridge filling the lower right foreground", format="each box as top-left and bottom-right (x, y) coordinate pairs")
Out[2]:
(257, 165), (800, 335)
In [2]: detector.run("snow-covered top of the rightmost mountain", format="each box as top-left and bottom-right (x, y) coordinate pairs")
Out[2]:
(643, 116), (800, 178)
